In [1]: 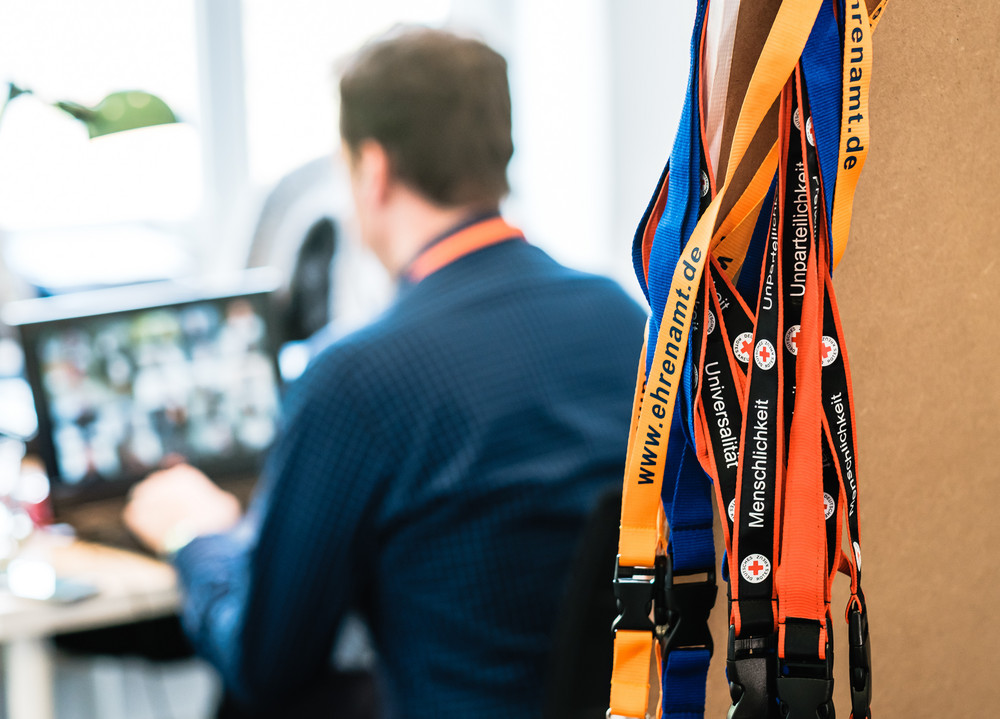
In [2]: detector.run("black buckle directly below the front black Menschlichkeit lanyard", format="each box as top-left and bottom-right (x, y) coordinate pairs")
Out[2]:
(726, 626), (779, 719)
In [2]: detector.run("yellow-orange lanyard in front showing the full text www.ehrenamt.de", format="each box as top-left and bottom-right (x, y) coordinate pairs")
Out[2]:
(610, 0), (819, 717)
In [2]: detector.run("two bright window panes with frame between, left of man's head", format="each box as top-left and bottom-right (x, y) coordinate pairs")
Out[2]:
(0, 0), (450, 290)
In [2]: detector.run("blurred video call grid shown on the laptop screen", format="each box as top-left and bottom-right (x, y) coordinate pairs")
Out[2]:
(10, 278), (279, 494)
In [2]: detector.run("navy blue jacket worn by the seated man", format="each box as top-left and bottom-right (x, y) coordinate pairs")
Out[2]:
(175, 226), (645, 719)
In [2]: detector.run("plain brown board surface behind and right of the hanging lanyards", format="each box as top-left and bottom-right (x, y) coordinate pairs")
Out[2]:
(707, 0), (1000, 719)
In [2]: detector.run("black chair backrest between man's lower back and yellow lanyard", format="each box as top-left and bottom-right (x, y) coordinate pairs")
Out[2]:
(542, 487), (621, 719)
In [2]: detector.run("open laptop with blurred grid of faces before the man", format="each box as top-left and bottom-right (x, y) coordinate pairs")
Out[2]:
(4, 268), (280, 548)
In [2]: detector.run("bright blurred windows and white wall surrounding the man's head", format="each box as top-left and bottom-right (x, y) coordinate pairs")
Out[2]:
(0, 0), (692, 304)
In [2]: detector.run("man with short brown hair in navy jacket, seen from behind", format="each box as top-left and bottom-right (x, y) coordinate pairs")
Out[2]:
(126, 30), (644, 719)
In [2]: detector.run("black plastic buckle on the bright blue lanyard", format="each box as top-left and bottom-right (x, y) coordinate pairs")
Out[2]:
(656, 557), (719, 656)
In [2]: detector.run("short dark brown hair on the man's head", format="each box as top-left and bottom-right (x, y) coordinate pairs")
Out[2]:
(340, 28), (514, 206)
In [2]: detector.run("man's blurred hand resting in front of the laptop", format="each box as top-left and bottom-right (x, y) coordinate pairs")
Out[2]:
(122, 464), (241, 554)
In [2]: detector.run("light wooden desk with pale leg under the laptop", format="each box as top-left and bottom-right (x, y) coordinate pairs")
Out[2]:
(0, 536), (180, 719)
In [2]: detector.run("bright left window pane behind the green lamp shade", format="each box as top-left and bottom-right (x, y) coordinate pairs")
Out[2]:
(0, 0), (202, 285)
